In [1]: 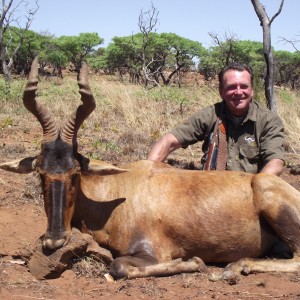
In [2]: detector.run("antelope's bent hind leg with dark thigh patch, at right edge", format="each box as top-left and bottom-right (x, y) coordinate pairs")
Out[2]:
(223, 174), (300, 279)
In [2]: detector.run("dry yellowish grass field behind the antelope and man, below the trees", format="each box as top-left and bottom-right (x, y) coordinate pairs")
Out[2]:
(0, 74), (300, 168)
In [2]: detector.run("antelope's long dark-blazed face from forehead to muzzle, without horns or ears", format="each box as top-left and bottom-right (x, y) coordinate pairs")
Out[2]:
(36, 139), (80, 249)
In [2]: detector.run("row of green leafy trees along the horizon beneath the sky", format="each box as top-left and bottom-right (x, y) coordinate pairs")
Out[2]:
(0, 26), (300, 91)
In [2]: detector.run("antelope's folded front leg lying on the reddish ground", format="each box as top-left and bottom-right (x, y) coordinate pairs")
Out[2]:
(110, 256), (207, 279)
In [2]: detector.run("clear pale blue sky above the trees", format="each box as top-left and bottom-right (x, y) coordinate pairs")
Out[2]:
(20, 0), (300, 52)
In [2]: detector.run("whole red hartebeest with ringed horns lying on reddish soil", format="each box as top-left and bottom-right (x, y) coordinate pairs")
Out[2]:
(0, 59), (300, 278)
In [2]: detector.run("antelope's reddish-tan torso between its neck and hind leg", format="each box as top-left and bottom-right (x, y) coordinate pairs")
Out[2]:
(79, 161), (273, 262)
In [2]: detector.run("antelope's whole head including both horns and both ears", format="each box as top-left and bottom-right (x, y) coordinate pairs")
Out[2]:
(0, 58), (127, 249)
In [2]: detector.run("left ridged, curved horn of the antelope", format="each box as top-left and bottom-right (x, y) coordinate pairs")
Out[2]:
(23, 56), (58, 142)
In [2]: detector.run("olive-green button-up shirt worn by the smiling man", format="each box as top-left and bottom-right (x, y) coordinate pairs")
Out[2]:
(171, 101), (285, 173)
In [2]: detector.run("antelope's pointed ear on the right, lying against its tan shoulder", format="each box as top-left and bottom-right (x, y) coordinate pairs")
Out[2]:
(82, 160), (128, 176)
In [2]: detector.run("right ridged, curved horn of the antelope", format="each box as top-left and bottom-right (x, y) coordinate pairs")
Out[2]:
(61, 62), (96, 145)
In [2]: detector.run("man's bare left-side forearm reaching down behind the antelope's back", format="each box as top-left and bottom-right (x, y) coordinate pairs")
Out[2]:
(147, 133), (182, 161)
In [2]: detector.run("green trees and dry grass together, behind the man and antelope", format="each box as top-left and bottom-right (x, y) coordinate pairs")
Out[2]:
(0, 6), (300, 162)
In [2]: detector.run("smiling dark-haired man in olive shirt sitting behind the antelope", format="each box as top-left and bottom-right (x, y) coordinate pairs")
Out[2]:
(148, 63), (285, 176)
